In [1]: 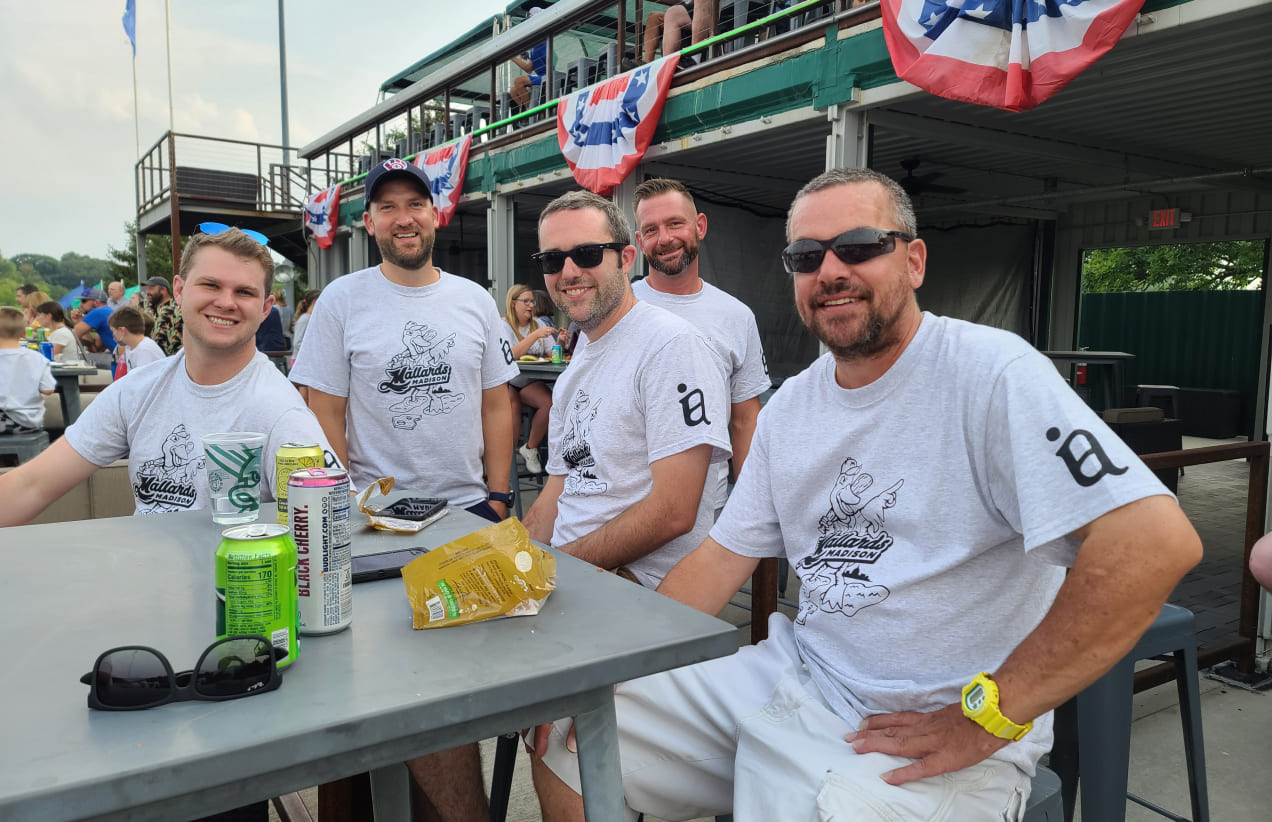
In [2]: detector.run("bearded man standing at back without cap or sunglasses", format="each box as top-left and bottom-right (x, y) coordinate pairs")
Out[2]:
(632, 178), (772, 512)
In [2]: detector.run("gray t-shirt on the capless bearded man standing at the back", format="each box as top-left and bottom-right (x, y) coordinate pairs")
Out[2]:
(632, 280), (773, 508)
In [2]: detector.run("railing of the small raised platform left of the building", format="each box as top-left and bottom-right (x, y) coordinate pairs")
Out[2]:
(135, 131), (335, 215)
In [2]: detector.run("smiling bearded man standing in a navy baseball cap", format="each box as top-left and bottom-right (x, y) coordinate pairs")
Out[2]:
(289, 158), (518, 822)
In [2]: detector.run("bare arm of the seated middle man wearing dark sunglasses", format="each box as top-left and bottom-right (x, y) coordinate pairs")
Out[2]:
(558, 444), (711, 569)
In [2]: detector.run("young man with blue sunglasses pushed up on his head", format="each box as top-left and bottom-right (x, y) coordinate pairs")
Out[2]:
(0, 223), (332, 526)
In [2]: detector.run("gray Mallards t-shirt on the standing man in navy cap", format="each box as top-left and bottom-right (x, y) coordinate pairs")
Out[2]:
(290, 267), (518, 508)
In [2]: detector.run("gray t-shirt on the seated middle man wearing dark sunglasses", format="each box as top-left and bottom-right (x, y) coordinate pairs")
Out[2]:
(547, 303), (730, 587)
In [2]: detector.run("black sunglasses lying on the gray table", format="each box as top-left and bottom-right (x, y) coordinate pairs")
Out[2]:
(80, 636), (287, 711)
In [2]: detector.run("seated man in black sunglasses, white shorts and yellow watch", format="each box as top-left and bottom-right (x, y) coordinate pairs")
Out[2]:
(536, 169), (1201, 822)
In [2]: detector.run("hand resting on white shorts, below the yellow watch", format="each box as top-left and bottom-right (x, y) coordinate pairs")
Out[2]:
(843, 704), (1009, 785)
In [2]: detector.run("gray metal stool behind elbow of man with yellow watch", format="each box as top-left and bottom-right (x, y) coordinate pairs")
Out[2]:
(1051, 604), (1210, 822)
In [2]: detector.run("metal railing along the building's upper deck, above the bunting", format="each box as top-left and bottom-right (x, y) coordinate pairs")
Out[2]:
(300, 0), (879, 194)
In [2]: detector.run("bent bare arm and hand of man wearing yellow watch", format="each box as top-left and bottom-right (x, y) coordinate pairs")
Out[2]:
(847, 496), (1201, 785)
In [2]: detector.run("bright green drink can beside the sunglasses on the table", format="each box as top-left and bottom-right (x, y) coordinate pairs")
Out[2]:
(216, 523), (300, 668)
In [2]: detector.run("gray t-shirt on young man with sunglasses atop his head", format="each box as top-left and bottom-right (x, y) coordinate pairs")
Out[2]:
(66, 351), (337, 514)
